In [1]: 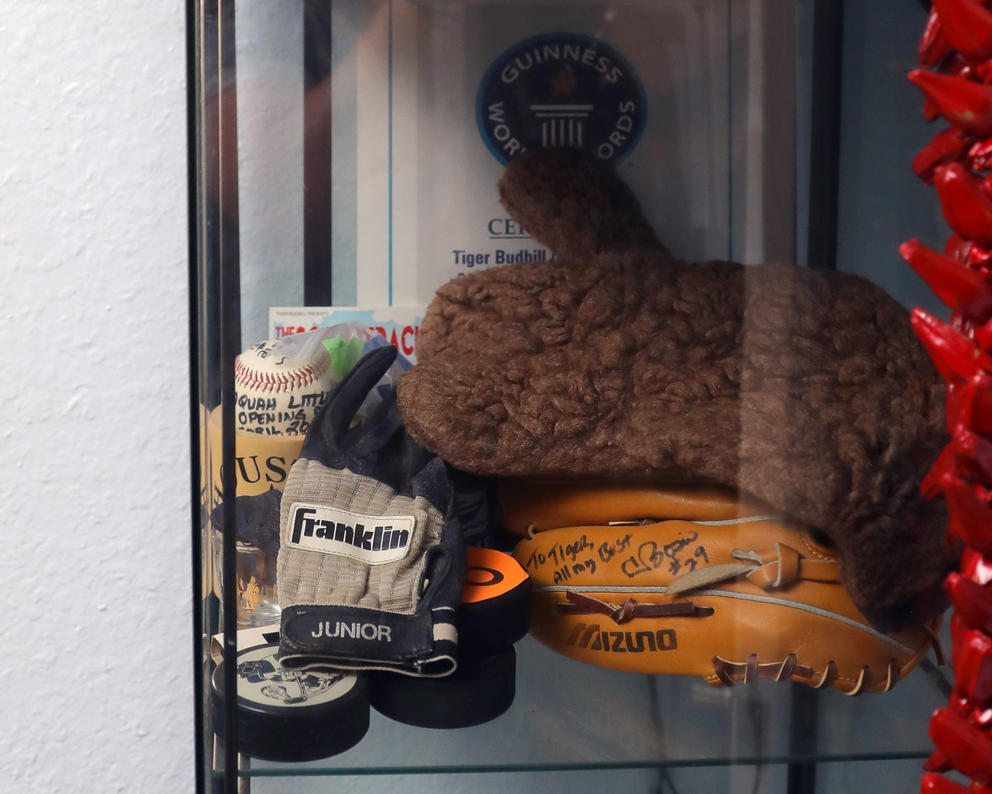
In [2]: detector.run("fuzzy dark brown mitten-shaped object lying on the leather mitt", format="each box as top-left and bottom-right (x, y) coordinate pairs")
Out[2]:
(399, 153), (950, 629)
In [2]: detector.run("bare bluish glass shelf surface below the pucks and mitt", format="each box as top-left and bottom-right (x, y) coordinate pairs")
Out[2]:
(218, 637), (950, 776)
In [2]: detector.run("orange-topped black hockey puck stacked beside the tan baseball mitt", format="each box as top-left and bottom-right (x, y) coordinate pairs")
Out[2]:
(458, 546), (530, 656)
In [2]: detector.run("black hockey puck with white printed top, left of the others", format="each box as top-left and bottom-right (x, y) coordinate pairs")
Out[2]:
(211, 644), (369, 761)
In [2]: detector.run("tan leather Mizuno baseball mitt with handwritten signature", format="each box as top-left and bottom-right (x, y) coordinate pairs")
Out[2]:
(508, 481), (939, 695)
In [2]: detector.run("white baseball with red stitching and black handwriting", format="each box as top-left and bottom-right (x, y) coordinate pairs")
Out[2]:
(234, 337), (335, 436)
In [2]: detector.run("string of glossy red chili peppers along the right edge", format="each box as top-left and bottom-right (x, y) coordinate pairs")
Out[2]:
(900, 10), (992, 794)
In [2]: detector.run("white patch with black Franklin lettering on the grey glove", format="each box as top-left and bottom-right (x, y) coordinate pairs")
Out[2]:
(286, 502), (416, 565)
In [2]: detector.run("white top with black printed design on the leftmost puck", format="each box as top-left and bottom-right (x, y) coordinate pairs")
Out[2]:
(237, 645), (357, 707)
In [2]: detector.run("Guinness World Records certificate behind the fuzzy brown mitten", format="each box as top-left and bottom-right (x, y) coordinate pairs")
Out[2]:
(354, 0), (754, 307)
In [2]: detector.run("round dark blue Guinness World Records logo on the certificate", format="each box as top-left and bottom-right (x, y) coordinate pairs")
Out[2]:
(476, 33), (646, 163)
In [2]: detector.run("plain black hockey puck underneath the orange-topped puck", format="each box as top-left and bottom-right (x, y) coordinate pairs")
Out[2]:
(369, 645), (517, 728)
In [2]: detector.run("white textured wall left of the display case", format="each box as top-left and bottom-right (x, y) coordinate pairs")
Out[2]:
(0, 0), (194, 794)
